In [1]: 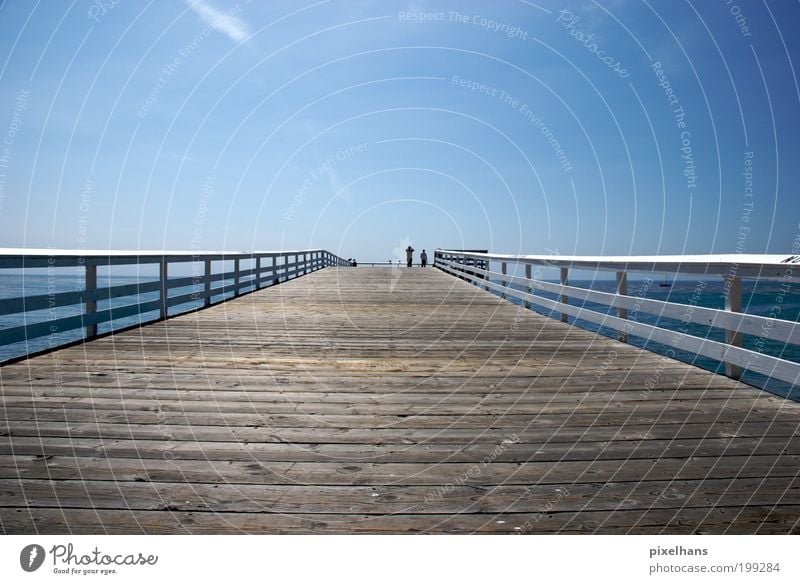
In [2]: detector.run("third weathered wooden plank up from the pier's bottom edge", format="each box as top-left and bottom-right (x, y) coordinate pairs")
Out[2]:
(0, 454), (800, 490)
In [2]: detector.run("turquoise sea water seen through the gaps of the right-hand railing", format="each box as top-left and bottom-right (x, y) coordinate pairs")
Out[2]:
(494, 279), (800, 400)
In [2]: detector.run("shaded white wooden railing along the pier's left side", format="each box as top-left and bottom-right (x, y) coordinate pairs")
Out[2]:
(0, 249), (349, 358)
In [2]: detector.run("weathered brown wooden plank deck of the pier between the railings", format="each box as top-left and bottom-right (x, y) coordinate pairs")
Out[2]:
(0, 268), (800, 533)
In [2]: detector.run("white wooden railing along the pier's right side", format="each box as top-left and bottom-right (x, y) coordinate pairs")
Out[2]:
(434, 250), (800, 385)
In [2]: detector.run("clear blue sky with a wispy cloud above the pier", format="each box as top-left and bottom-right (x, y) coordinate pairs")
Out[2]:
(0, 0), (800, 261)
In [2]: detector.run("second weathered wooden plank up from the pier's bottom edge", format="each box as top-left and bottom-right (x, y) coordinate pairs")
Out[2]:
(0, 477), (800, 515)
